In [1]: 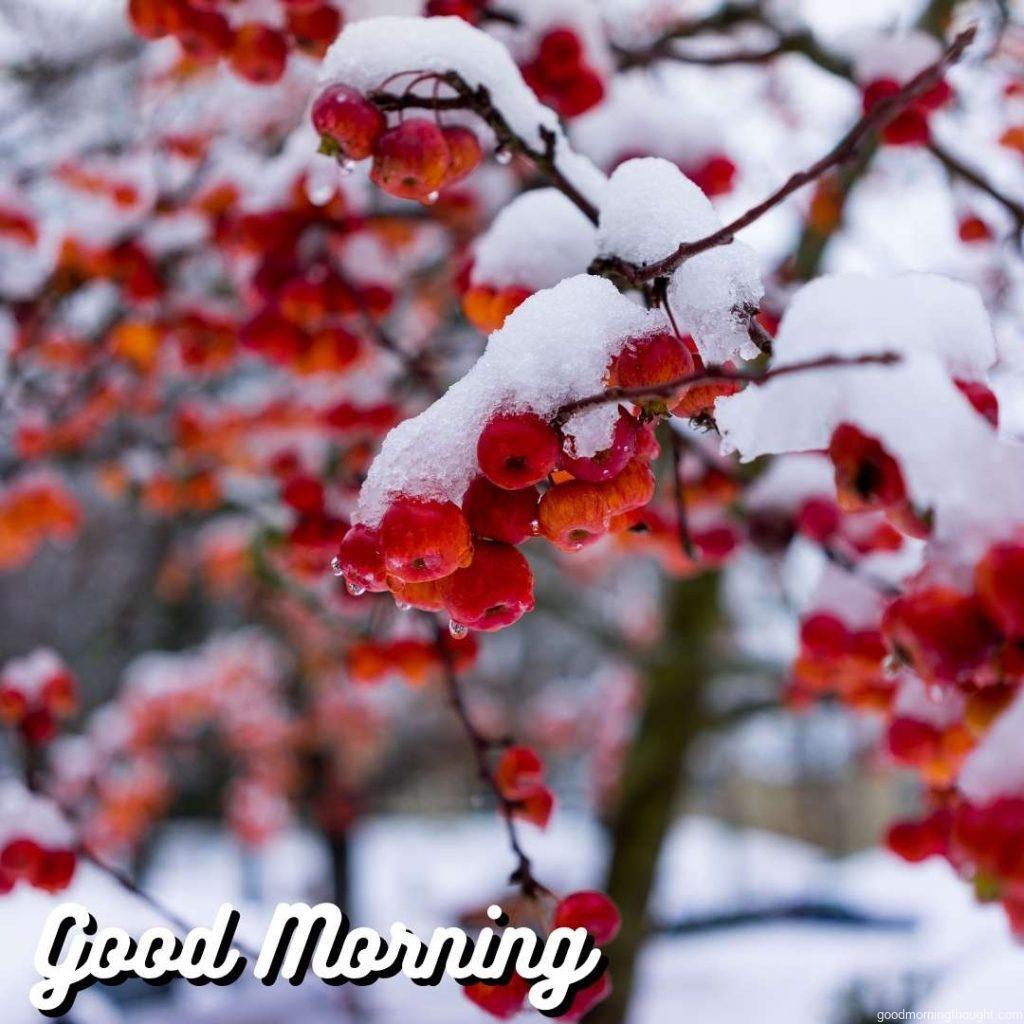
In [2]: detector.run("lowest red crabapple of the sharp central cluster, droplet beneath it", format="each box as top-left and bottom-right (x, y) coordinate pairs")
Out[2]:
(441, 541), (534, 633)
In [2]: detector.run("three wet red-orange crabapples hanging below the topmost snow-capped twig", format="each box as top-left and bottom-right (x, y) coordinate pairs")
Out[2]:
(311, 84), (483, 203)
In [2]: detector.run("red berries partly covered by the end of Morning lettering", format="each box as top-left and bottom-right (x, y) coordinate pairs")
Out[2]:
(463, 890), (622, 1022)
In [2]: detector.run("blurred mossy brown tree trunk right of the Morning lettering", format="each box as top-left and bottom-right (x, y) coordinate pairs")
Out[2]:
(587, 573), (719, 1024)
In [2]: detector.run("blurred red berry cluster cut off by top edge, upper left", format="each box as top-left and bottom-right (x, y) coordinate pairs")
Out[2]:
(128, 0), (342, 85)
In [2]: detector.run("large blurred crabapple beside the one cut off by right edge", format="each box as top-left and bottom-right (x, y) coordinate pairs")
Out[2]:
(882, 586), (996, 683)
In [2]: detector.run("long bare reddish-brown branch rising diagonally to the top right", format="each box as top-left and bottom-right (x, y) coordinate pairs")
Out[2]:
(590, 27), (977, 288)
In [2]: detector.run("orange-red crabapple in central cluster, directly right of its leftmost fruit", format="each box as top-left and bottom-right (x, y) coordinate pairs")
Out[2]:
(381, 497), (473, 583)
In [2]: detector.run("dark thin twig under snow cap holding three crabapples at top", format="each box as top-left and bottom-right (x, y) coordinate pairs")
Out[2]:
(369, 72), (598, 224)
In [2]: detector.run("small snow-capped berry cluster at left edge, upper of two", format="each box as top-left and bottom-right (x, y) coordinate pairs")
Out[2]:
(0, 650), (78, 745)
